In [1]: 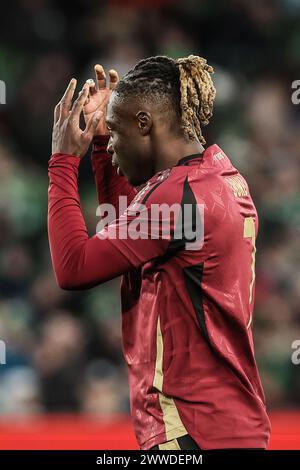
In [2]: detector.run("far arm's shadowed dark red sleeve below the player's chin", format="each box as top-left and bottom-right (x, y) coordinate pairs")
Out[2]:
(92, 136), (137, 211)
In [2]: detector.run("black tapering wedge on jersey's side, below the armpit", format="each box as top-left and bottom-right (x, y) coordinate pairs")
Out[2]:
(183, 263), (210, 344)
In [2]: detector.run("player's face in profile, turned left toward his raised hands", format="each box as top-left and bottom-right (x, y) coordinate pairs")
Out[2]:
(106, 93), (155, 186)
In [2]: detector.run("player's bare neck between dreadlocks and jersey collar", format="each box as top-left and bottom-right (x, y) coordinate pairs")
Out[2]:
(155, 137), (204, 173)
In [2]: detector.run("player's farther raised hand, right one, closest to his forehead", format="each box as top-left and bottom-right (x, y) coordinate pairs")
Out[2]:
(83, 64), (119, 136)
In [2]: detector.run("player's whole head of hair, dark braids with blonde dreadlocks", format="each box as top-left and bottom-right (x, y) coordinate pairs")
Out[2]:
(115, 55), (216, 144)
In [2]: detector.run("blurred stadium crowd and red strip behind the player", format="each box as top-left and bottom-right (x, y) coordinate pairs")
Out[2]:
(0, 0), (300, 449)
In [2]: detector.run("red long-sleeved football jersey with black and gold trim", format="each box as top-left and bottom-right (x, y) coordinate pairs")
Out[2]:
(48, 139), (270, 449)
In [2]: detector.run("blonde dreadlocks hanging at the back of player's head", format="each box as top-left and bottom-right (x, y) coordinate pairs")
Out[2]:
(177, 55), (216, 144)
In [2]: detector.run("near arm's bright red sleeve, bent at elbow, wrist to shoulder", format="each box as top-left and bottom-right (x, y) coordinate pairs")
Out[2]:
(48, 154), (180, 289)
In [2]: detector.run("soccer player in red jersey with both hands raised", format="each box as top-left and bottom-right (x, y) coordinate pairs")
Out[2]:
(48, 56), (270, 450)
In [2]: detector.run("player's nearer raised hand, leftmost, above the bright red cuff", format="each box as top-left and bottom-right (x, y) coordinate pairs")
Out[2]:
(52, 78), (103, 158)
